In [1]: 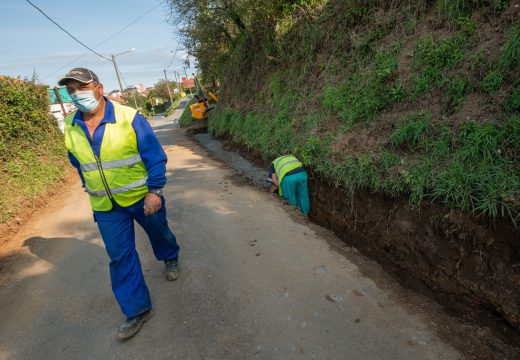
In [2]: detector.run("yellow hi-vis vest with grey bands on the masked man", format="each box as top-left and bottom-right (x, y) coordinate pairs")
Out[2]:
(64, 102), (148, 211)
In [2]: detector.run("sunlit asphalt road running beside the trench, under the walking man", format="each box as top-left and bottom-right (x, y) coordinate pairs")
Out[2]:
(0, 107), (459, 360)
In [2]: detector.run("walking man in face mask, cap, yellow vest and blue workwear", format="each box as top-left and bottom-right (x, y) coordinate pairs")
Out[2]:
(58, 68), (179, 339)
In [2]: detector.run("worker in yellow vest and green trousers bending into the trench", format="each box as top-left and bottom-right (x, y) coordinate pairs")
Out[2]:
(269, 155), (311, 216)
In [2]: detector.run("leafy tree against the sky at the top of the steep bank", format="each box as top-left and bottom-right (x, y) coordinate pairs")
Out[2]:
(165, 0), (316, 81)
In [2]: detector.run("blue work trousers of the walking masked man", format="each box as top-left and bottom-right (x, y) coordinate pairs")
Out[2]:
(94, 198), (179, 319)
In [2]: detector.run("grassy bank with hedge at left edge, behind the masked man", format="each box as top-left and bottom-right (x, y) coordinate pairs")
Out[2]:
(0, 77), (66, 224)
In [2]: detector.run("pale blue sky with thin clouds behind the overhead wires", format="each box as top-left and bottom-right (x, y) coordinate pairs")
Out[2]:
(0, 0), (194, 93)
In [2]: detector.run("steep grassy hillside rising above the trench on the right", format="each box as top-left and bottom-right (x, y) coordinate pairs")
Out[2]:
(209, 0), (520, 225)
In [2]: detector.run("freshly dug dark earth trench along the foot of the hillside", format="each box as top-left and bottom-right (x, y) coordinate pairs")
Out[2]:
(193, 131), (520, 359)
